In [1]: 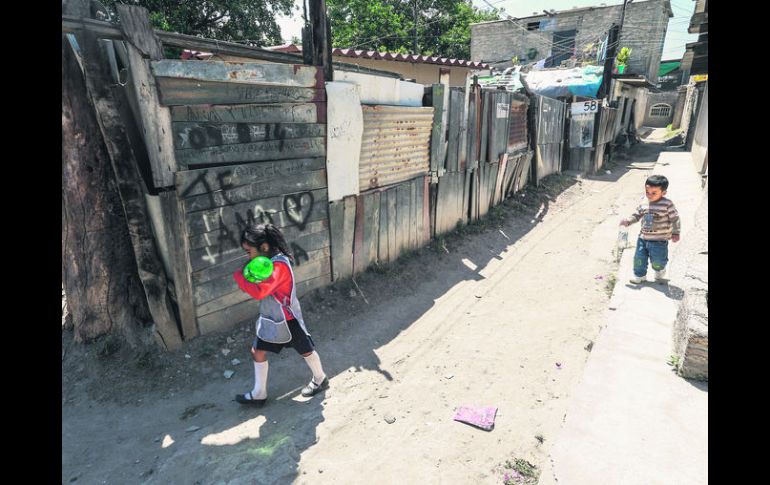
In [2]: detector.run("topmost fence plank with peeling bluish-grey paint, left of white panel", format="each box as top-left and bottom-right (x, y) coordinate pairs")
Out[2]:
(152, 59), (318, 88)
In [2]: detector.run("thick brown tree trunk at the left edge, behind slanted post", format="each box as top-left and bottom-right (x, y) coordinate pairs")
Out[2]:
(62, 36), (152, 346)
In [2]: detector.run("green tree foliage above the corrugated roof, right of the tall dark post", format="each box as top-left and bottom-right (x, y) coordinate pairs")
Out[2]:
(326, 0), (499, 59)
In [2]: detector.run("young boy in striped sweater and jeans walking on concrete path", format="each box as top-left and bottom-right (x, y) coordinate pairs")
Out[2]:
(620, 175), (680, 284)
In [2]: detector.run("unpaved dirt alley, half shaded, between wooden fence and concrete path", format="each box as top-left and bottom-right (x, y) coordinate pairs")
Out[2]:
(62, 148), (646, 484)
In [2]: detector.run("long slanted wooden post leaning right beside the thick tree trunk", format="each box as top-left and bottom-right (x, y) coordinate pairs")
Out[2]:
(68, 0), (182, 350)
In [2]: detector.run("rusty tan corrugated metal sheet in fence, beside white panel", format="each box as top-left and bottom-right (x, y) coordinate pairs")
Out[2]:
(358, 105), (433, 191)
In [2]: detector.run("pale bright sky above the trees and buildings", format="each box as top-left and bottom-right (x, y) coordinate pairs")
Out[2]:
(277, 0), (698, 60)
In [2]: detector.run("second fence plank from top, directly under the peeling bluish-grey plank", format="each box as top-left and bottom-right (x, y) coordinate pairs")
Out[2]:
(156, 77), (326, 105)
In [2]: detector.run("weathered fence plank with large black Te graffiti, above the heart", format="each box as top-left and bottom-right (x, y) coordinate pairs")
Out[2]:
(174, 157), (326, 197)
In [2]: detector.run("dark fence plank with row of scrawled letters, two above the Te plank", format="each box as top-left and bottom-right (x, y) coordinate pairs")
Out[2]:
(173, 122), (326, 150)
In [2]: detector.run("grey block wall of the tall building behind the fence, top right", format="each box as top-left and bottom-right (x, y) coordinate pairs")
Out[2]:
(471, 0), (671, 83)
